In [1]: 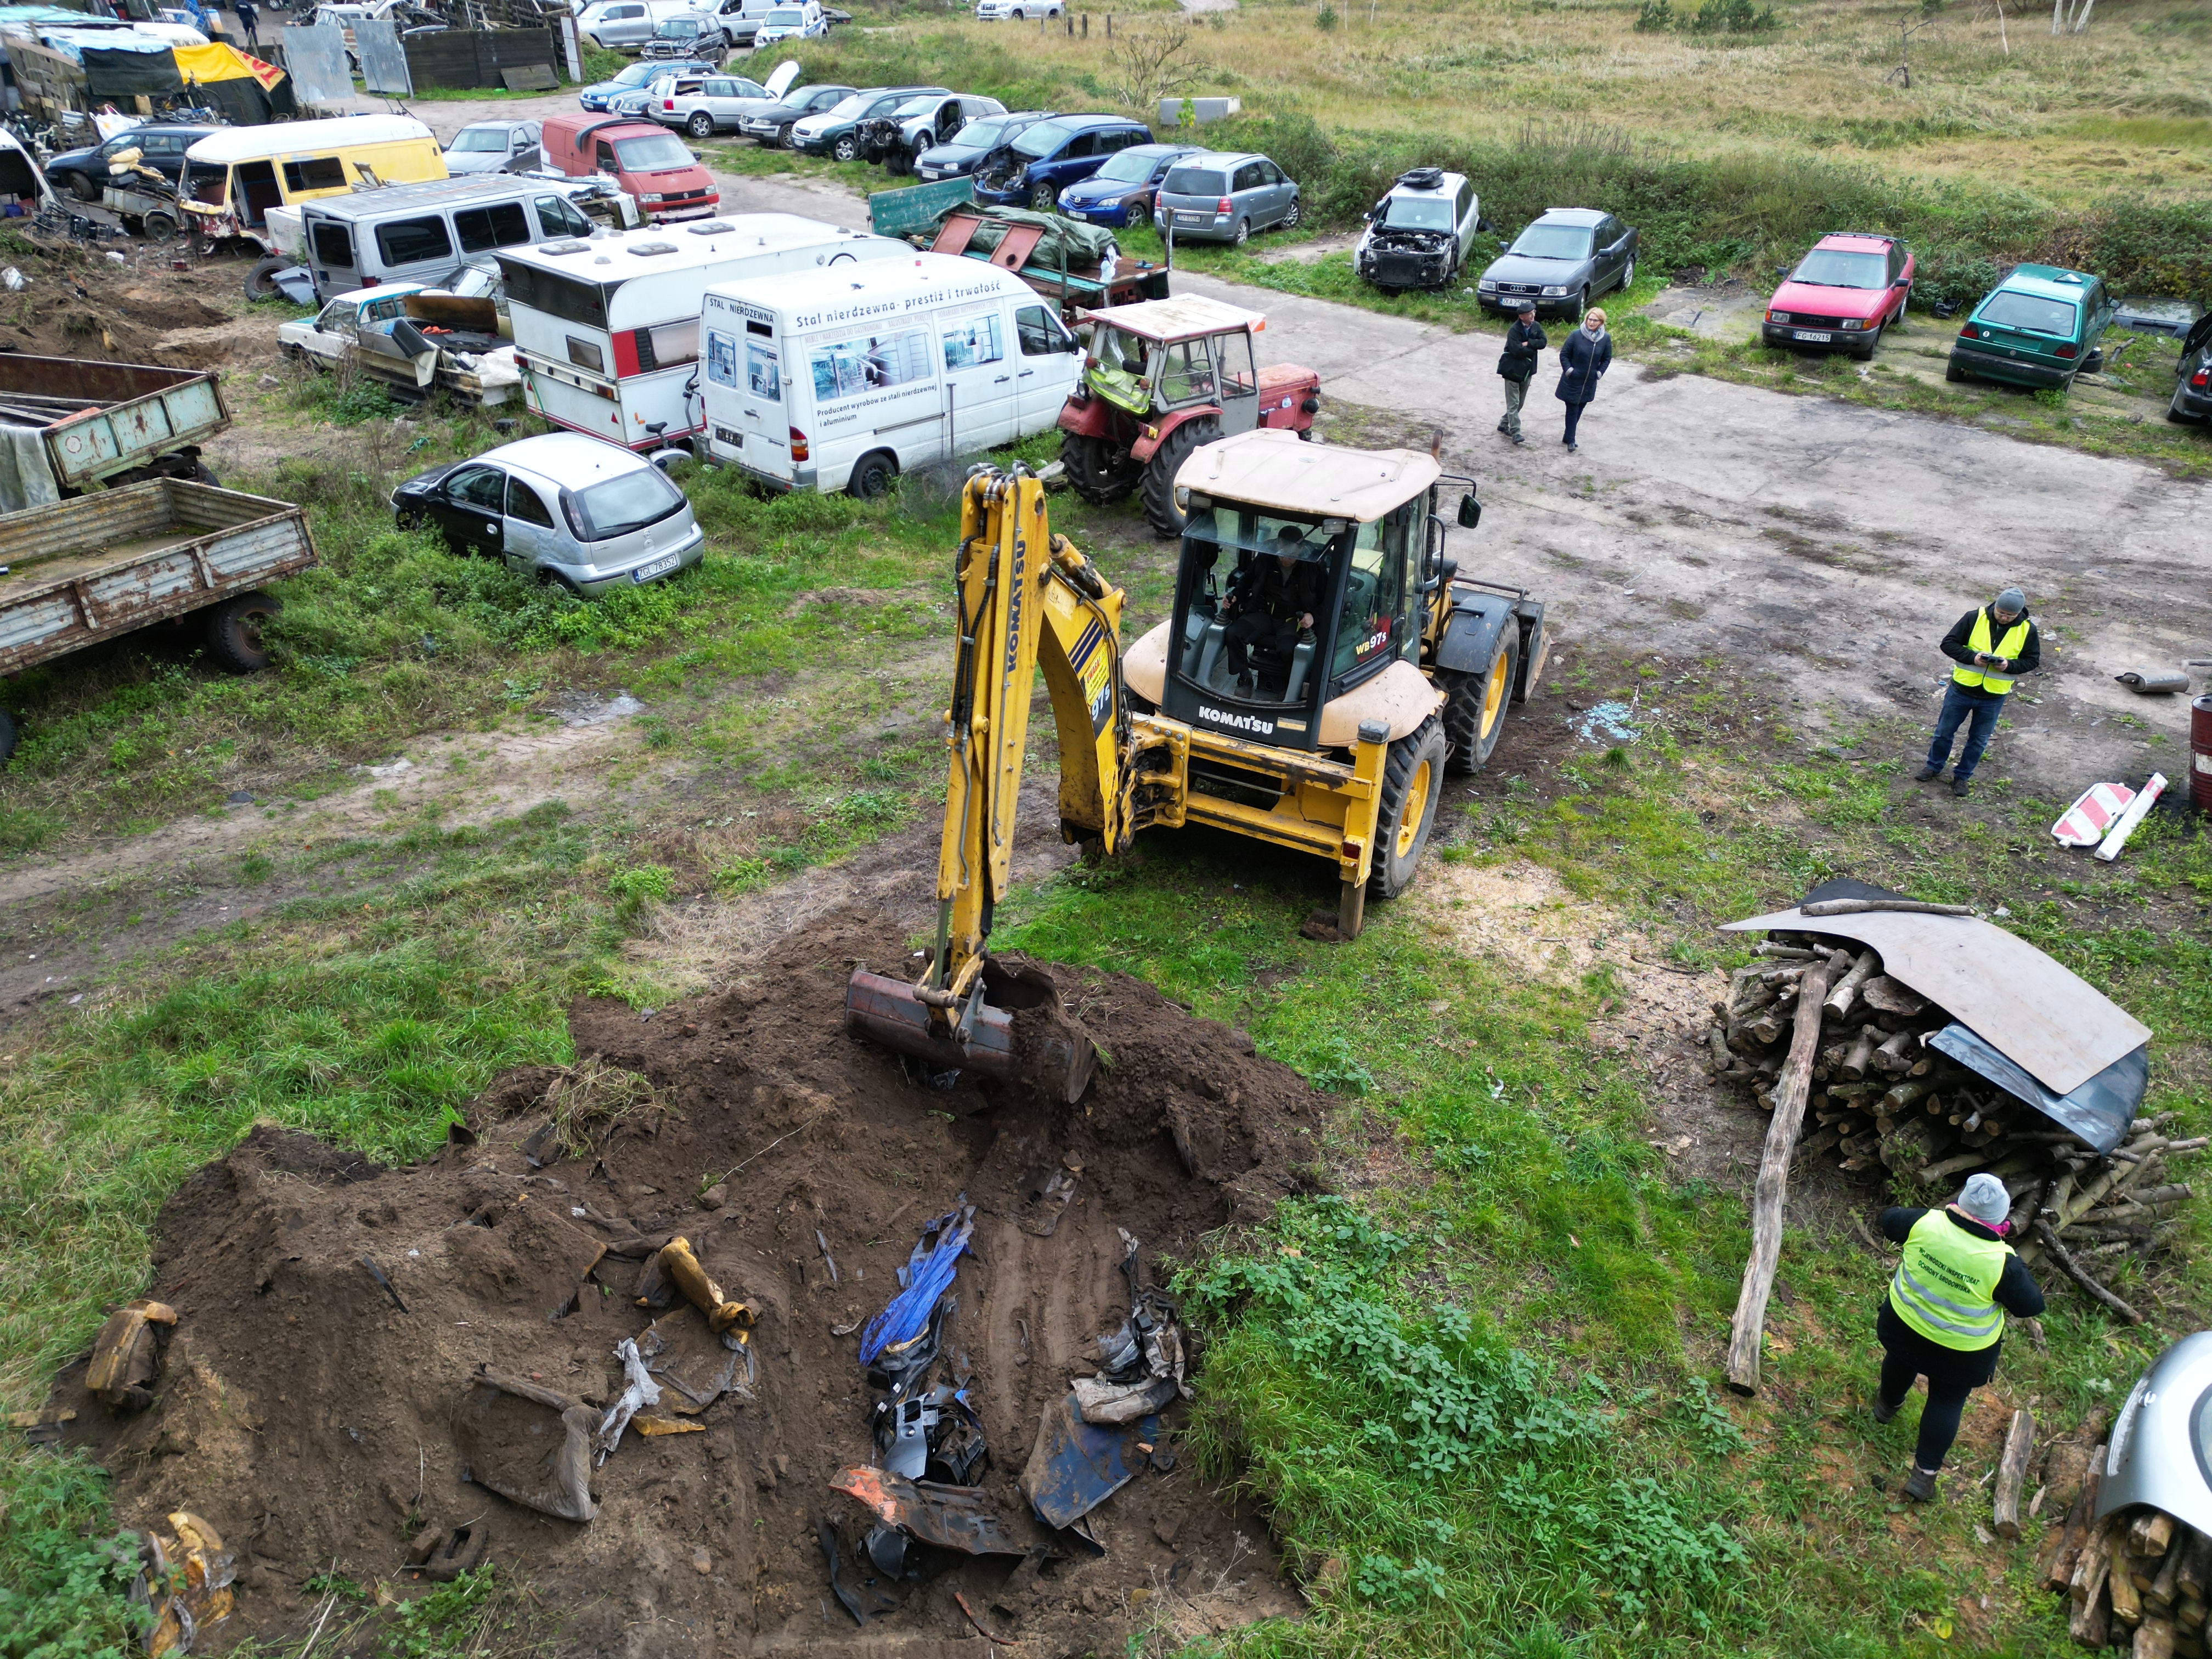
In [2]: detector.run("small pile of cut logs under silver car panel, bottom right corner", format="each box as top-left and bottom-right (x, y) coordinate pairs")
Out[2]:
(2037, 1447), (2212, 1659)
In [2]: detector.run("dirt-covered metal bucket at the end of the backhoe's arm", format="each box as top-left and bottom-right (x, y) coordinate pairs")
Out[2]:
(845, 960), (1097, 1106)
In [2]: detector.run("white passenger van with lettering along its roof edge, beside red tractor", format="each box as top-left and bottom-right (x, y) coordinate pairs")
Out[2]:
(703, 255), (1084, 495)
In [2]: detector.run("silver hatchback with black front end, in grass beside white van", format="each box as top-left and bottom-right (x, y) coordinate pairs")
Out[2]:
(392, 431), (706, 600)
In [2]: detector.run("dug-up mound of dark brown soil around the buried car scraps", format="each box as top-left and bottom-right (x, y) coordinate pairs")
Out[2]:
(53, 913), (1321, 1659)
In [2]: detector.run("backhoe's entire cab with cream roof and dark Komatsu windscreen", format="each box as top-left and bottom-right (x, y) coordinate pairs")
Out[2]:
(1124, 431), (1442, 750)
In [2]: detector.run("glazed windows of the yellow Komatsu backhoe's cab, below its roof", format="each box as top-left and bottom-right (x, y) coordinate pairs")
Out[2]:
(1161, 477), (1431, 750)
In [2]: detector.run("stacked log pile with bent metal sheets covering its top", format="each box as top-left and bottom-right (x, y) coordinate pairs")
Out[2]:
(1708, 885), (2205, 1323)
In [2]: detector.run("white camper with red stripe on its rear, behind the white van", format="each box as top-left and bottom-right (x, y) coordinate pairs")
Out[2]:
(498, 212), (902, 462)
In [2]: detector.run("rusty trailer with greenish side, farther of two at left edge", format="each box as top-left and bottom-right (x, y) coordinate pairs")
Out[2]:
(0, 352), (230, 511)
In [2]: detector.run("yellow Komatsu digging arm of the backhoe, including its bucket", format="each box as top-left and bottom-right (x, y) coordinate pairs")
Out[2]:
(845, 467), (1130, 1102)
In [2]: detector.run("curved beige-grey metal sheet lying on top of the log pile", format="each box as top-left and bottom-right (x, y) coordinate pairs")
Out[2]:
(1721, 905), (2150, 1095)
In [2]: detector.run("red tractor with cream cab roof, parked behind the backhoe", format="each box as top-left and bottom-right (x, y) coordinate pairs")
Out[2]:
(1059, 294), (1321, 535)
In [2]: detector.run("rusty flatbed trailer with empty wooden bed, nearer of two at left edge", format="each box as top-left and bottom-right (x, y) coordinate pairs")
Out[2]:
(0, 478), (317, 759)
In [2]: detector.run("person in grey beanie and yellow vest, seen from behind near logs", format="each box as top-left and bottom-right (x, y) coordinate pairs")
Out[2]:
(1874, 1175), (2044, 1502)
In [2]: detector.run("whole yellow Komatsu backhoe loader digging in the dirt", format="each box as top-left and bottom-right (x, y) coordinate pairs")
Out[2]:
(845, 431), (1548, 1102)
